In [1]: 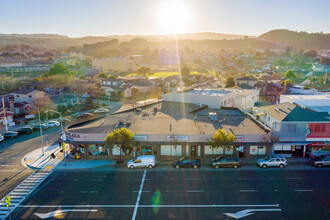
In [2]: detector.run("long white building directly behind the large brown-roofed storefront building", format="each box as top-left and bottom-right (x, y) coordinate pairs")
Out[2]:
(163, 88), (259, 111)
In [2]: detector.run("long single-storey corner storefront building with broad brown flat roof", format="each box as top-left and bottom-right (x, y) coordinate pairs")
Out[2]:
(66, 101), (271, 159)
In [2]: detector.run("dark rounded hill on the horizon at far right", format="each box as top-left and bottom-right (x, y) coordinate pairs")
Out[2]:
(258, 29), (330, 49)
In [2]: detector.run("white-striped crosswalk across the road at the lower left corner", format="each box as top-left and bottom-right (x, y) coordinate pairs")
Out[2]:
(0, 169), (52, 219)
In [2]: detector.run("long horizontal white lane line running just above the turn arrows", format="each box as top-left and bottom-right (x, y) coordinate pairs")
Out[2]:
(17, 204), (280, 208)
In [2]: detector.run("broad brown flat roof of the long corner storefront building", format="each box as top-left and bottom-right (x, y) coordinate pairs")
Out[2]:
(68, 101), (266, 135)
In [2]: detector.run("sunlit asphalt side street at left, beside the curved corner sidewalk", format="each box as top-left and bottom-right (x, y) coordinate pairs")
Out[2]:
(0, 127), (61, 199)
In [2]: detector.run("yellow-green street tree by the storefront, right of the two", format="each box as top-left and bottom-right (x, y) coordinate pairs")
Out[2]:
(208, 129), (235, 150)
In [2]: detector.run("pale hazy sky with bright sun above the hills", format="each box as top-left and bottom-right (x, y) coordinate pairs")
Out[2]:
(0, 0), (330, 37)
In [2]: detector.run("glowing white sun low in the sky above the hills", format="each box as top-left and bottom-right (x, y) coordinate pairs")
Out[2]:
(157, 0), (190, 34)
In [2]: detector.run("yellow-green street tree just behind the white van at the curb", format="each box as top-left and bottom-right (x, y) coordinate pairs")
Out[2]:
(105, 128), (134, 160)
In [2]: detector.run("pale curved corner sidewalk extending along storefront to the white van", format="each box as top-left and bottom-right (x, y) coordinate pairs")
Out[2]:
(22, 144), (116, 170)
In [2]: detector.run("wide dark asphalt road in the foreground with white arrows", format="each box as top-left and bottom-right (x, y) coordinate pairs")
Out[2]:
(12, 169), (330, 220)
